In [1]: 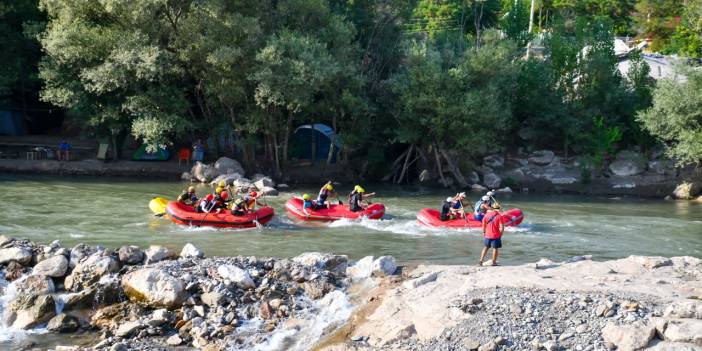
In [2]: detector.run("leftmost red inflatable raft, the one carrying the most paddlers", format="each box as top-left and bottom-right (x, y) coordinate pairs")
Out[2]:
(166, 201), (273, 228)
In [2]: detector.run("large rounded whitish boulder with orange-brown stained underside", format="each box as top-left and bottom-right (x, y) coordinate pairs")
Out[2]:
(122, 268), (186, 309)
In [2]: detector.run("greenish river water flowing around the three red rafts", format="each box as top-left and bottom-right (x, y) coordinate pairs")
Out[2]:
(0, 175), (702, 264)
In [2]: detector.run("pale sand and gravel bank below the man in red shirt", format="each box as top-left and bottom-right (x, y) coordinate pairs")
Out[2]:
(323, 256), (702, 351)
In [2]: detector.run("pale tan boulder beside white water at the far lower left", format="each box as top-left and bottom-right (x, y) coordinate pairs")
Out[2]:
(6, 294), (56, 329)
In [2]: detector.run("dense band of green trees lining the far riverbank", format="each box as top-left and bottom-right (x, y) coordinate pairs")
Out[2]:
(0, 0), (702, 185)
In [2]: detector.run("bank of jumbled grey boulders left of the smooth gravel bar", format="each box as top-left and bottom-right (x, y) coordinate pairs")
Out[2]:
(0, 236), (396, 350)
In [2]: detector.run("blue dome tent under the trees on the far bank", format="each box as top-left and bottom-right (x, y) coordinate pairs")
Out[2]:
(290, 123), (341, 162)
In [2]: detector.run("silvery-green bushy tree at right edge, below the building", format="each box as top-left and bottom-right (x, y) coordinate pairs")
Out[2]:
(638, 69), (702, 165)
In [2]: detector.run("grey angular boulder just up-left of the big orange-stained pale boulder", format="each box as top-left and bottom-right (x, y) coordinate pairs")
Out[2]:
(64, 253), (121, 292)
